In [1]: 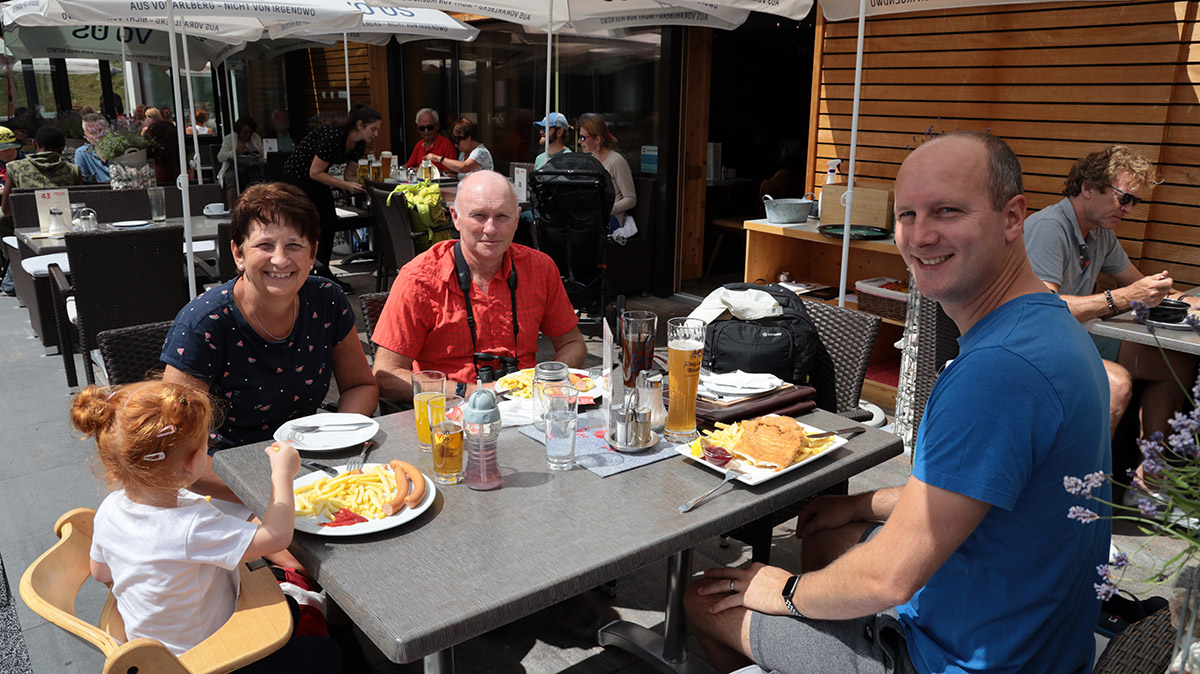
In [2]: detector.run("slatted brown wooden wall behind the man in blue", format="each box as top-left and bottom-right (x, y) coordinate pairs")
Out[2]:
(809, 0), (1200, 285)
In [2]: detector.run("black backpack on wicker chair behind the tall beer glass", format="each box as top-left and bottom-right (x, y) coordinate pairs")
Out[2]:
(703, 283), (824, 385)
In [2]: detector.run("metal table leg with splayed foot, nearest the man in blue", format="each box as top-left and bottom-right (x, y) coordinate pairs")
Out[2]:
(596, 549), (714, 674)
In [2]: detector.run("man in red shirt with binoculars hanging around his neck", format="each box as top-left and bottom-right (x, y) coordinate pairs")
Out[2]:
(372, 170), (587, 401)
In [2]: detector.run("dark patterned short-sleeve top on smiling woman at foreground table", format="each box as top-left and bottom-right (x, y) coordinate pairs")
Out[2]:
(162, 276), (355, 449)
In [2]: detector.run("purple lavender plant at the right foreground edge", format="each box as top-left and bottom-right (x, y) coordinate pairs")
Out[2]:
(1063, 302), (1200, 674)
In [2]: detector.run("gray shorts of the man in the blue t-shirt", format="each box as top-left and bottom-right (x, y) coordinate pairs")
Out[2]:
(750, 524), (917, 674)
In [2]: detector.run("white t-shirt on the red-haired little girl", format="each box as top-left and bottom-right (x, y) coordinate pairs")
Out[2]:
(91, 489), (258, 655)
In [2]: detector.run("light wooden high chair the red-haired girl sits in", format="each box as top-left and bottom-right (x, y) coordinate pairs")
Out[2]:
(20, 507), (292, 674)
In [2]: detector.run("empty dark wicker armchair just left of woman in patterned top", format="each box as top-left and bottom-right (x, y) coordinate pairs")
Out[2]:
(50, 227), (188, 387)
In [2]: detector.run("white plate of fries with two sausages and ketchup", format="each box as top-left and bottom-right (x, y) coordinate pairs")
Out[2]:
(292, 463), (437, 536)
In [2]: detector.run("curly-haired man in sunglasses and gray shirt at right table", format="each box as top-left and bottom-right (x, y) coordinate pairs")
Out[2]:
(1025, 145), (1200, 477)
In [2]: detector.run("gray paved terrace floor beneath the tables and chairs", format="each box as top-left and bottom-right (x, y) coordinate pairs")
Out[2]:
(0, 254), (1172, 674)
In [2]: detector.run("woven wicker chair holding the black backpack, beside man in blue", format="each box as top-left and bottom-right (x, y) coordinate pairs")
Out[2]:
(728, 299), (883, 564)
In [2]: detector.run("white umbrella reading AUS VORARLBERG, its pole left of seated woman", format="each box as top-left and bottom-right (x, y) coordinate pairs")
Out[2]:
(23, 0), (362, 296)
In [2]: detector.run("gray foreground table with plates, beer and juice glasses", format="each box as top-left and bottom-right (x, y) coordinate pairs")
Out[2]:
(214, 410), (902, 673)
